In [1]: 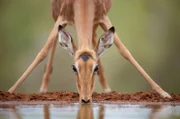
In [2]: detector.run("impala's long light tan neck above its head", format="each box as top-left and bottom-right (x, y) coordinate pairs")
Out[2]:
(74, 0), (95, 49)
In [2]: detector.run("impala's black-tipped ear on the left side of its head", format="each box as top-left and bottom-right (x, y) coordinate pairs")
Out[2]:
(58, 25), (76, 56)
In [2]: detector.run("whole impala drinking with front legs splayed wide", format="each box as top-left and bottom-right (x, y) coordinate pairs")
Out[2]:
(9, 0), (170, 103)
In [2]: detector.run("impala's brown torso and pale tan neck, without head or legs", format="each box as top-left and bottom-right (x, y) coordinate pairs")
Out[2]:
(52, 0), (112, 48)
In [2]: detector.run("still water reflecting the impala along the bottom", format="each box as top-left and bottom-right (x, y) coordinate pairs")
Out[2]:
(0, 103), (180, 119)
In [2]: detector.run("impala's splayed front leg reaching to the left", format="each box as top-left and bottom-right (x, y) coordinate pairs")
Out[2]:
(8, 16), (65, 93)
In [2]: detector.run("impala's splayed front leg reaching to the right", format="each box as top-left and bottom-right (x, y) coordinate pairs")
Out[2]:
(100, 16), (171, 98)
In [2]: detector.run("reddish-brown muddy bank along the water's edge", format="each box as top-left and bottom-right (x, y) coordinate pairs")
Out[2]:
(0, 91), (180, 103)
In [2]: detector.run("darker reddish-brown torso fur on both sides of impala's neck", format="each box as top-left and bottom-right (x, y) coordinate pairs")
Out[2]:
(51, 0), (113, 22)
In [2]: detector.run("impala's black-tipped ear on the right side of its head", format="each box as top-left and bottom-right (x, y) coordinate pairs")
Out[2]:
(95, 27), (115, 57)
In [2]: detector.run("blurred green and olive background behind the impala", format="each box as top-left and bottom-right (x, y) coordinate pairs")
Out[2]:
(0, 0), (180, 93)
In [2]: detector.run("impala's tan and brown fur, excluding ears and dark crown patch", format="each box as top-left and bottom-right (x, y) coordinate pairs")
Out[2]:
(8, 0), (171, 100)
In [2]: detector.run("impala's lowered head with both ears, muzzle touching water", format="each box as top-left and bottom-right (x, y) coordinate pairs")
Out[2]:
(58, 26), (115, 103)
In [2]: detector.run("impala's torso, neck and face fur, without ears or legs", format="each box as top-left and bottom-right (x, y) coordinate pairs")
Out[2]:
(52, 0), (112, 100)
